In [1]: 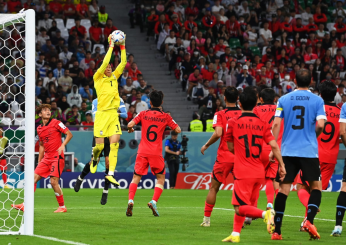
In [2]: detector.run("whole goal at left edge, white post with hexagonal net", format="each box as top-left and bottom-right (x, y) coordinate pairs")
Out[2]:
(0, 10), (35, 235)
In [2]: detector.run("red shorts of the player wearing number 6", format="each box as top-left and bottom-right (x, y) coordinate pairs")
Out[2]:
(134, 154), (166, 175)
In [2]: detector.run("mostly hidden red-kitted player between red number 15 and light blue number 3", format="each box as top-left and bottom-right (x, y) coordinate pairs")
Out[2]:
(253, 88), (283, 209)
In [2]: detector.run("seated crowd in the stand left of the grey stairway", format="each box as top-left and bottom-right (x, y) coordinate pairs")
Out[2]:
(0, 0), (151, 130)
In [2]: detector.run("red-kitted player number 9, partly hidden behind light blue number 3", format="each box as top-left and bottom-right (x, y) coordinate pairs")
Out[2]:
(297, 81), (341, 230)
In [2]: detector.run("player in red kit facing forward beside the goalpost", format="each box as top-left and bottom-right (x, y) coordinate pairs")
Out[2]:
(11, 104), (72, 213)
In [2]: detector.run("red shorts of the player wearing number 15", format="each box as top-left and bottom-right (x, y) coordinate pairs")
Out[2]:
(232, 178), (263, 207)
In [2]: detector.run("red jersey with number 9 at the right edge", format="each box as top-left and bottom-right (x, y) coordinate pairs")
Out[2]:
(317, 102), (340, 163)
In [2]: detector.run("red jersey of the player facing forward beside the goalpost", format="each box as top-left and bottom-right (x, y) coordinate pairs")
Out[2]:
(37, 119), (68, 156)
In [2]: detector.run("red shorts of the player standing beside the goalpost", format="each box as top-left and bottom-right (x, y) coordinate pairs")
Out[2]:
(35, 153), (65, 178)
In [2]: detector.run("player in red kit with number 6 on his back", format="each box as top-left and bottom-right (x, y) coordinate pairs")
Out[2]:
(126, 90), (181, 216)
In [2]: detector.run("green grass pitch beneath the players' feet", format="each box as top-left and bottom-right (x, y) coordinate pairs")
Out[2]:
(0, 189), (346, 245)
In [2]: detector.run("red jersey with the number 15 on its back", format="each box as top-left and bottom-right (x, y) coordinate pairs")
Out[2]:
(225, 113), (275, 179)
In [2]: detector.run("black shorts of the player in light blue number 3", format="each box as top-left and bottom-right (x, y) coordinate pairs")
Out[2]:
(282, 157), (321, 182)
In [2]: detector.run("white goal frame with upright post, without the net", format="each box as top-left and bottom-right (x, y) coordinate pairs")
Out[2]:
(0, 9), (36, 236)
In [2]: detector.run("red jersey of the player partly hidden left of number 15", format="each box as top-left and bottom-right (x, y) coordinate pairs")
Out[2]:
(213, 107), (241, 163)
